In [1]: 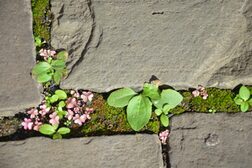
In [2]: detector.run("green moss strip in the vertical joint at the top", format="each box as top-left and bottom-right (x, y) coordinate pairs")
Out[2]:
(31, 0), (52, 41)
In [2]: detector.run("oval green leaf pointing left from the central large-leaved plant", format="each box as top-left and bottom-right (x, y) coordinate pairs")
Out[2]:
(107, 88), (137, 107)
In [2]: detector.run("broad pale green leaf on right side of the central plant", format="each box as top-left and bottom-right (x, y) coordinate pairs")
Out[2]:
(161, 89), (183, 108)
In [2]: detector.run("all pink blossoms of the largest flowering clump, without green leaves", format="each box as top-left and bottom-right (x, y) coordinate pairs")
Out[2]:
(21, 90), (94, 131)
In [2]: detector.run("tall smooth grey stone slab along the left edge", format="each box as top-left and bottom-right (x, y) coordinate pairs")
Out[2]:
(0, 0), (40, 116)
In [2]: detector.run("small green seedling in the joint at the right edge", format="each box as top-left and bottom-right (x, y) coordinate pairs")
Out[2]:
(234, 86), (252, 112)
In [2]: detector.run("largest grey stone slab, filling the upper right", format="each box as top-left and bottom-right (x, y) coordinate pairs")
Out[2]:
(49, 0), (252, 91)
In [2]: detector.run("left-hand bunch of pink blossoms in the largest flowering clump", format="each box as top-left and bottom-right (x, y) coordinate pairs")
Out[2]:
(21, 101), (50, 131)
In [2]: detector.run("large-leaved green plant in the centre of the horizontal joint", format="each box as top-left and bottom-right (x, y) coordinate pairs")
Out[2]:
(107, 83), (183, 131)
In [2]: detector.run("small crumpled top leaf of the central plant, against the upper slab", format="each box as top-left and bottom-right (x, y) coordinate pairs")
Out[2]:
(143, 83), (160, 100)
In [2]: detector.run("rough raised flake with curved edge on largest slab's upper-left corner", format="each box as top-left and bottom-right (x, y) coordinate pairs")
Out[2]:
(51, 0), (93, 69)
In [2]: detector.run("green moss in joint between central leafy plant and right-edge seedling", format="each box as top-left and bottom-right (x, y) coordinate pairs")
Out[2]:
(189, 88), (240, 112)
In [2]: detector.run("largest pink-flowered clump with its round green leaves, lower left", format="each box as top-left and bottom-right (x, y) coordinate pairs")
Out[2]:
(22, 89), (94, 139)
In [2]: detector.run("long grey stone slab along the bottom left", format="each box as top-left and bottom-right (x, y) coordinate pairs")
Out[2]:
(0, 134), (163, 168)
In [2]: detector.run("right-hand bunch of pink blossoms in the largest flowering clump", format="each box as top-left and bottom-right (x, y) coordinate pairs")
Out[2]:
(66, 90), (94, 126)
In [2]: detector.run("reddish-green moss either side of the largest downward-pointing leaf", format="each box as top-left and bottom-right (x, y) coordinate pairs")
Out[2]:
(82, 95), (159, 135)
